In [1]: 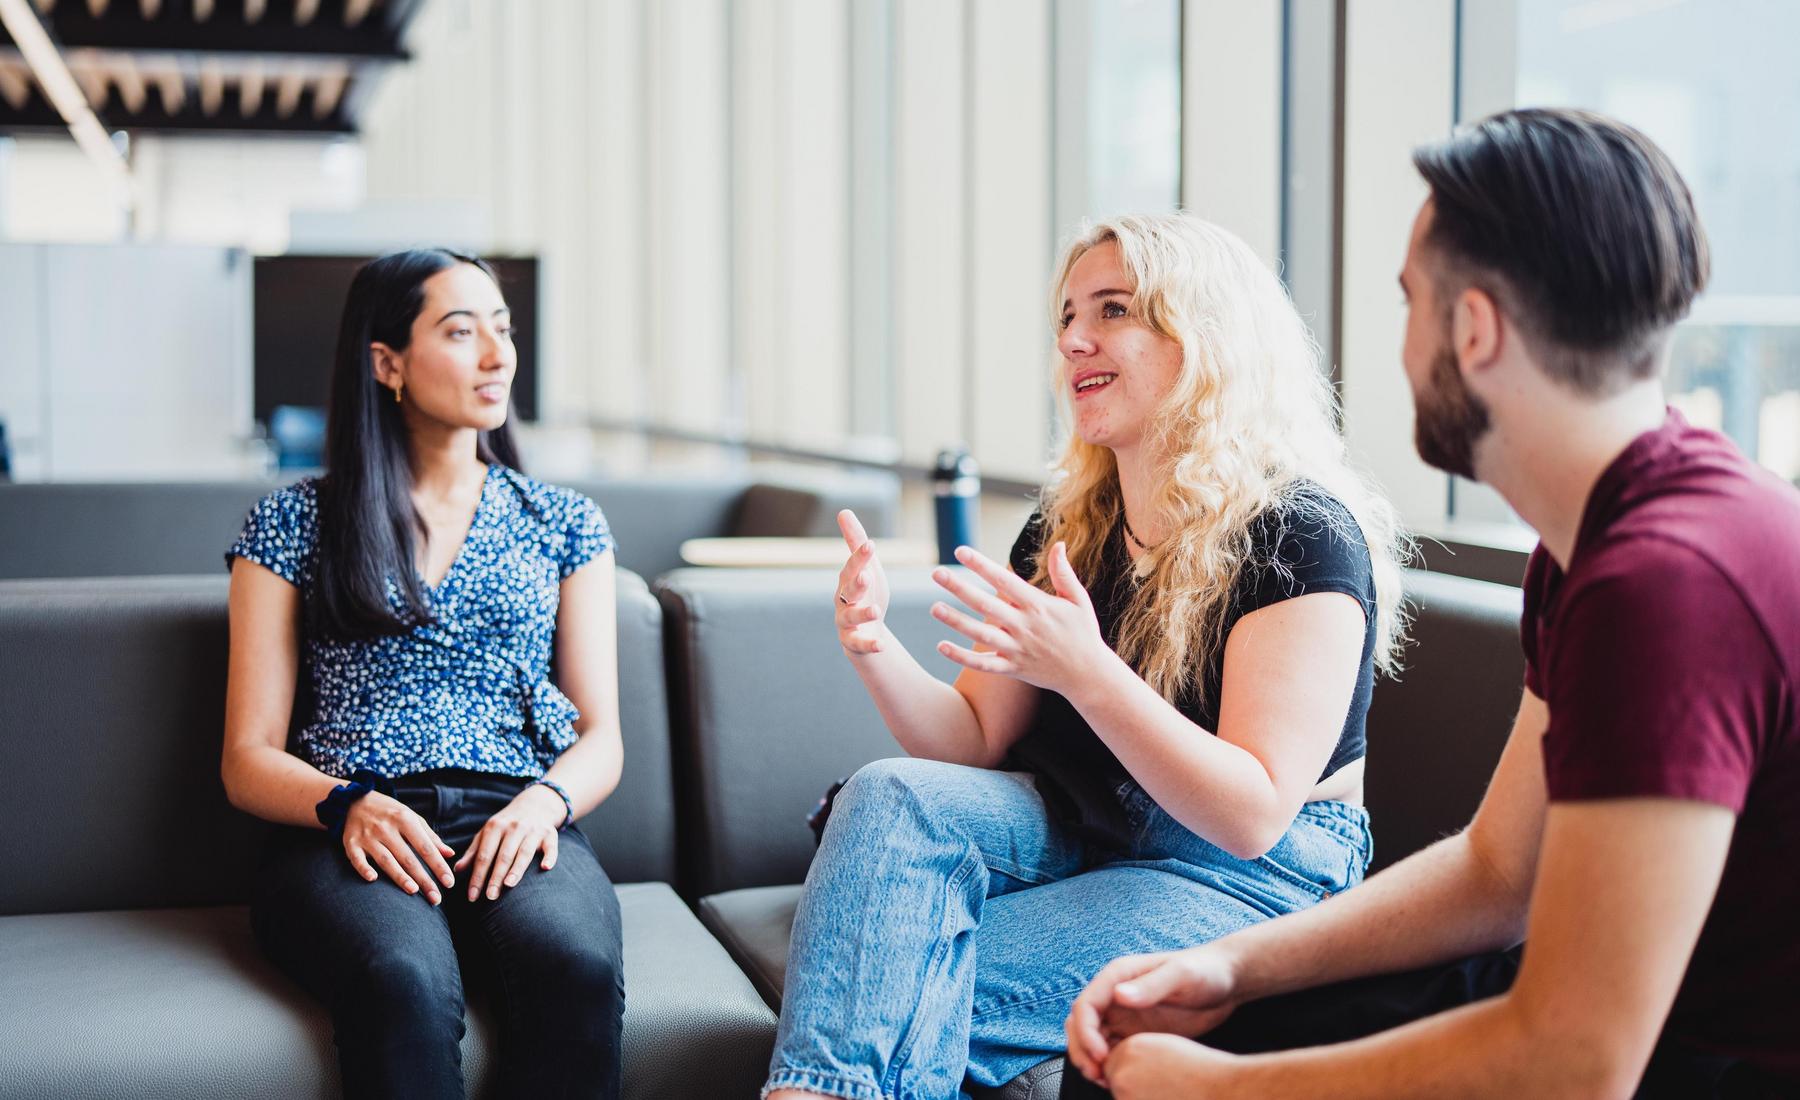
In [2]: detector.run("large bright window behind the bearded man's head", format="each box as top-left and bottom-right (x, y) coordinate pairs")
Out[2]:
(1454, 0), (1800, 518)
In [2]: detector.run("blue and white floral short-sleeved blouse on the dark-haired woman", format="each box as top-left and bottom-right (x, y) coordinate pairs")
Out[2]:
(225, 464), (612, 778)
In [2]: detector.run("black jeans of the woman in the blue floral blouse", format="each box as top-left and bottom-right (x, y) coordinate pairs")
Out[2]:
(250, 771), (625, 1100)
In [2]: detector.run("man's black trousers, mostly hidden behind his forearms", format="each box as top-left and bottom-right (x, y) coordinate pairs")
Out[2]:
(1062, 949), (1793, 1100)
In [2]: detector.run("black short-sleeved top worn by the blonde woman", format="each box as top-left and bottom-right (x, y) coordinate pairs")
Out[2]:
(1010, 481), (1375, 841)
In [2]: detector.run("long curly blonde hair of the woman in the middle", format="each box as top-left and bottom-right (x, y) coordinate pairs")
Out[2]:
(1030, 214), (1411, 702)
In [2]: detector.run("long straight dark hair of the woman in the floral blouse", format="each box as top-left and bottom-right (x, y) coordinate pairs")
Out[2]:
(308, 248), (520, 637)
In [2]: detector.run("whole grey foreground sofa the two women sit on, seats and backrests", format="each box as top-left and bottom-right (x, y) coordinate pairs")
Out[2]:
(0, 569), (1521, 1098)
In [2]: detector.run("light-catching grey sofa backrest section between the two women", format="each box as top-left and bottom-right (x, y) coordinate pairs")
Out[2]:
(657, 569), (958, 897)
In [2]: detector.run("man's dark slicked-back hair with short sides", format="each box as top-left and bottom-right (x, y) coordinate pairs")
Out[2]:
(1413, 110), (1710, 396)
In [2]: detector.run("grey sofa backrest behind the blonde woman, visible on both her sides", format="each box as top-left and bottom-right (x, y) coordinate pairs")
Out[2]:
(657, 569), (1521, 897)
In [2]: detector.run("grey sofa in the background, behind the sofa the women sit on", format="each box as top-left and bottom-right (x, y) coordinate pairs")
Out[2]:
(0, 472), (900, 580)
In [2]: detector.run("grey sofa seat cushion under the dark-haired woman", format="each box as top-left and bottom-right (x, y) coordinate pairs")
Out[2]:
(0, 882), (774, 1100)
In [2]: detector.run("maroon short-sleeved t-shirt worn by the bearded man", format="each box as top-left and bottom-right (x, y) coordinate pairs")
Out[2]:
(1521, 410), (1800, 1077)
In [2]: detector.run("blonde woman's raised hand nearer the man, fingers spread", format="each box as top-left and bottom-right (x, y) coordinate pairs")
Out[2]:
(931, 542), (1112, 695)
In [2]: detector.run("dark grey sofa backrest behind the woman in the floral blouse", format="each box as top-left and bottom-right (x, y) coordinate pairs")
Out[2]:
(0, 571), (675, 915)
